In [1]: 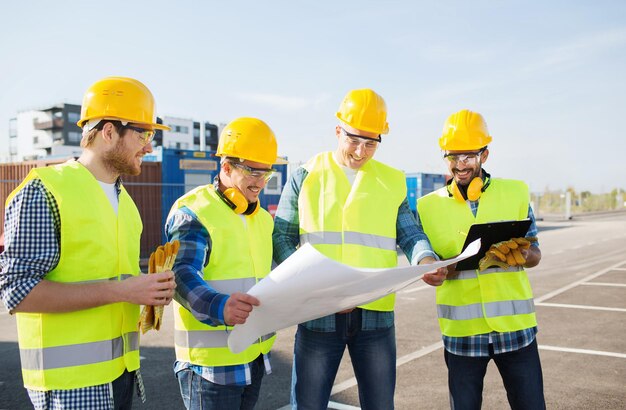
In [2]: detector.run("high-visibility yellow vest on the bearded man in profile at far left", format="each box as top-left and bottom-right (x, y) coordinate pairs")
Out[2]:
(7, 161), (143, 391)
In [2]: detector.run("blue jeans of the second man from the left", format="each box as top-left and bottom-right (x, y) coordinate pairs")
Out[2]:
(176, 355), (265, 410)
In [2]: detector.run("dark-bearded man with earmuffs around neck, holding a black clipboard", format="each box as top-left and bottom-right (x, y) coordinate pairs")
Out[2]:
(417, 110), (545, 409)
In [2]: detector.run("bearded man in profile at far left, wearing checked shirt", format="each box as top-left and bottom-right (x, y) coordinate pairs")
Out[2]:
(0, 77), (175, 409)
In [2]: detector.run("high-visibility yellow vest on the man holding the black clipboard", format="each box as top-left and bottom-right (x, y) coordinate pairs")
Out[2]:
(417, 179), (537, 337)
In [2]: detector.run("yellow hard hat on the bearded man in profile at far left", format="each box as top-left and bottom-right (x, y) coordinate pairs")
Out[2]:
(76, 77), (170, 130)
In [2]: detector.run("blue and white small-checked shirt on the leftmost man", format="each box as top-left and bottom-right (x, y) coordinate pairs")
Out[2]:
(0, 179), (145, 410)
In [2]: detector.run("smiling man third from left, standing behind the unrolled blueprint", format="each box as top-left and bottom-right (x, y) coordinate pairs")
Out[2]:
(273, 89), (445, 410)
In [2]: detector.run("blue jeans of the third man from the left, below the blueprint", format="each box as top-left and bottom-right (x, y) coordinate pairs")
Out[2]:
(291, 309), (396, 410)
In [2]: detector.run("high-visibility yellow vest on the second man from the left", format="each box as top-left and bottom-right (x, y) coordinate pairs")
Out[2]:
(170, 185), (276, 367)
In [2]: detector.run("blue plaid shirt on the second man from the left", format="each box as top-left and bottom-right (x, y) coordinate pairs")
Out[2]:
(165, 207), (272, 386)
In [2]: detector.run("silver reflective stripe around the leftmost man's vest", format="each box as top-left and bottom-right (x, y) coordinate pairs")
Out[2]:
(20, 332), (139, 370)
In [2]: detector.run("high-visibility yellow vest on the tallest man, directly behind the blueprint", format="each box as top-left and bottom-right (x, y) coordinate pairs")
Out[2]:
(298, 152), (406, 311)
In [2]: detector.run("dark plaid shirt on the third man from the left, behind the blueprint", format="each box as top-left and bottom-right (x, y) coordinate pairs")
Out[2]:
(273, 167), (437, 332)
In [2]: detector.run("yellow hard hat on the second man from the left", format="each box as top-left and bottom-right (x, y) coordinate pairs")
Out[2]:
(215, 117), (285, 165)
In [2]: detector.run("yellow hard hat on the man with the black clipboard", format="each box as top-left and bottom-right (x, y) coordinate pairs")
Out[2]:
(439, 110), (492, 151)
